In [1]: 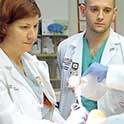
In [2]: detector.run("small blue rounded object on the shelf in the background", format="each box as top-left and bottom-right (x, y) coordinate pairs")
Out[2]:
(47, 23), (64, 33)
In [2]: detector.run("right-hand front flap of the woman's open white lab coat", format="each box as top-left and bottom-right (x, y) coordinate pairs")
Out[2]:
(23, 55), (56, 104)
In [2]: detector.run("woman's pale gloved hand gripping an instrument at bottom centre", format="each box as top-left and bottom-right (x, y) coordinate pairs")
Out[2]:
(64, 103), (88, 124)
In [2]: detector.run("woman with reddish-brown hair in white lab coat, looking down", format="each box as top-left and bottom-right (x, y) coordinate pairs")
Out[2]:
(0, 0), (87, 124)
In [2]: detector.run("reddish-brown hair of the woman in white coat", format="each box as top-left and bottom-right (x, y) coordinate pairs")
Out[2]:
(0, 0), (41, 43)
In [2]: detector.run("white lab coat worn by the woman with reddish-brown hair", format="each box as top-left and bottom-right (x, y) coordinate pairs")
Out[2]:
(0, 49), (64, 124)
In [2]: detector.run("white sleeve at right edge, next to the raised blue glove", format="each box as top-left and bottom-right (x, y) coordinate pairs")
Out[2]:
(106, 65), (124, 91)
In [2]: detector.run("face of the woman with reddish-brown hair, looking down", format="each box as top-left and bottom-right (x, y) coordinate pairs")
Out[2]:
(5, 16), (39, 53)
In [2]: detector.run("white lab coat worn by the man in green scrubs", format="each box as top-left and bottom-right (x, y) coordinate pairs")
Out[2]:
(58, 29), (124, 118)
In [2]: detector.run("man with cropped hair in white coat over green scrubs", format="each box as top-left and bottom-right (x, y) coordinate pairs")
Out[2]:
(58, 0), (124, 118)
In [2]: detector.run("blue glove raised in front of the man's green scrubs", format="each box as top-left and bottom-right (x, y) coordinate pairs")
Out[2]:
(83, 62), (108, 82)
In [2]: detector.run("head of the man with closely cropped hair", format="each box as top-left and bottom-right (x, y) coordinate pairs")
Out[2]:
(80, 0), (116, 33)
